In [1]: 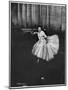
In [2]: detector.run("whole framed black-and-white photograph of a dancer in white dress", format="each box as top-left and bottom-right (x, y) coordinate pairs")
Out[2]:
(9, 1), (66, 88)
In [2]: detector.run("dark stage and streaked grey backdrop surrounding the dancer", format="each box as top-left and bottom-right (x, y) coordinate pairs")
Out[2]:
(10, 3), (66, 87)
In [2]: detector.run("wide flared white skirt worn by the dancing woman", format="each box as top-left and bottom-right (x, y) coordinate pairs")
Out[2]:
(32, 35), (59, 61)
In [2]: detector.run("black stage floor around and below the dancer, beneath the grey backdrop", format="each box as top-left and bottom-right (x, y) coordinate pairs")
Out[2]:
(11, 30), (65, 87)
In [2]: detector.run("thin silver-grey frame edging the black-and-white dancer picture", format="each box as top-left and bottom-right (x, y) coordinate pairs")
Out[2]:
(9, 1), (67, 89)
